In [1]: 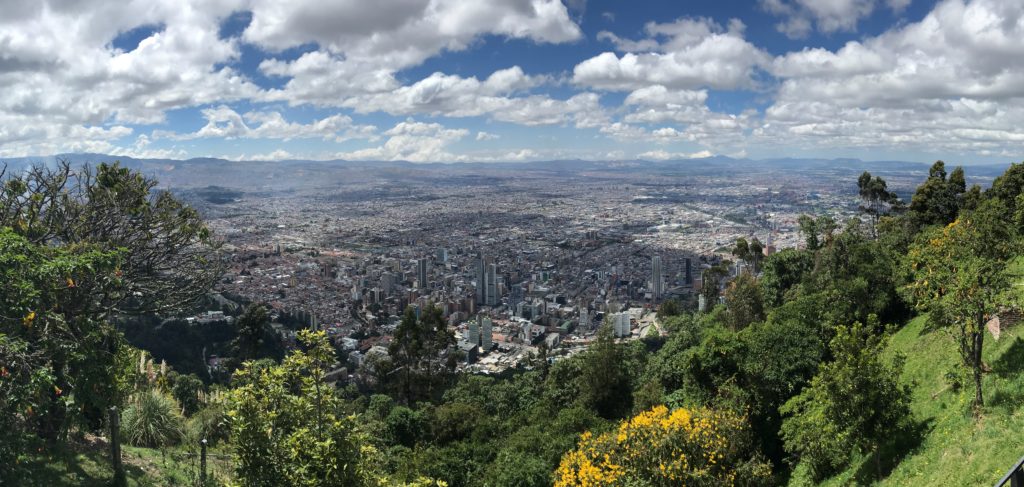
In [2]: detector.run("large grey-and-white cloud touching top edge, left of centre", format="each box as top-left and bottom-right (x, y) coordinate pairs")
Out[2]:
(243, 0), (582, 104)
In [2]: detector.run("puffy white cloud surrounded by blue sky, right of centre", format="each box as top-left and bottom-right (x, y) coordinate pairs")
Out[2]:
(572, 18), (771, 91)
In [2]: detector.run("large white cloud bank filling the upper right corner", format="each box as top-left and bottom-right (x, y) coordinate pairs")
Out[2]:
(754, 0), (1024, 153)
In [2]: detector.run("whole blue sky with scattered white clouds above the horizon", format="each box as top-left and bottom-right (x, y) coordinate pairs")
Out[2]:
(0, 0), (1024, 164)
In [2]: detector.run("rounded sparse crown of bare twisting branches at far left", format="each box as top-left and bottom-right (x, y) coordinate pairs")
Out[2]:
(0, 162), (222, 313)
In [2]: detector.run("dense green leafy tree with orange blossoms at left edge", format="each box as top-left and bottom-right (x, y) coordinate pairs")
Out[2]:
(0, 227), (128, 442)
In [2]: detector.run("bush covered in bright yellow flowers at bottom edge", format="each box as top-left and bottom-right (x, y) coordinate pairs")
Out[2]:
(555, 406), (770, 487)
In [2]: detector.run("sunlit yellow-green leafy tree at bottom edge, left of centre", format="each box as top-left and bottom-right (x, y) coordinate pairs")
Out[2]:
(227, 330), (368, 487)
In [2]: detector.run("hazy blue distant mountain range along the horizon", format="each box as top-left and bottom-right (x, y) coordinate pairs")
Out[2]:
(0, 153), (1009, 189)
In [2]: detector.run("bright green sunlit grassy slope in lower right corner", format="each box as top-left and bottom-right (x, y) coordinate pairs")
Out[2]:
(791, 316), (1024, 485)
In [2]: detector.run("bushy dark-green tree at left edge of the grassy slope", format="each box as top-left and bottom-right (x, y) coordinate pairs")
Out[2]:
(780, 322), (911, 479)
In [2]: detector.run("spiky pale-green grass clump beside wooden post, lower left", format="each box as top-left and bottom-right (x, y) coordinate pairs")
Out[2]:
(121, 389), (184, 447)
